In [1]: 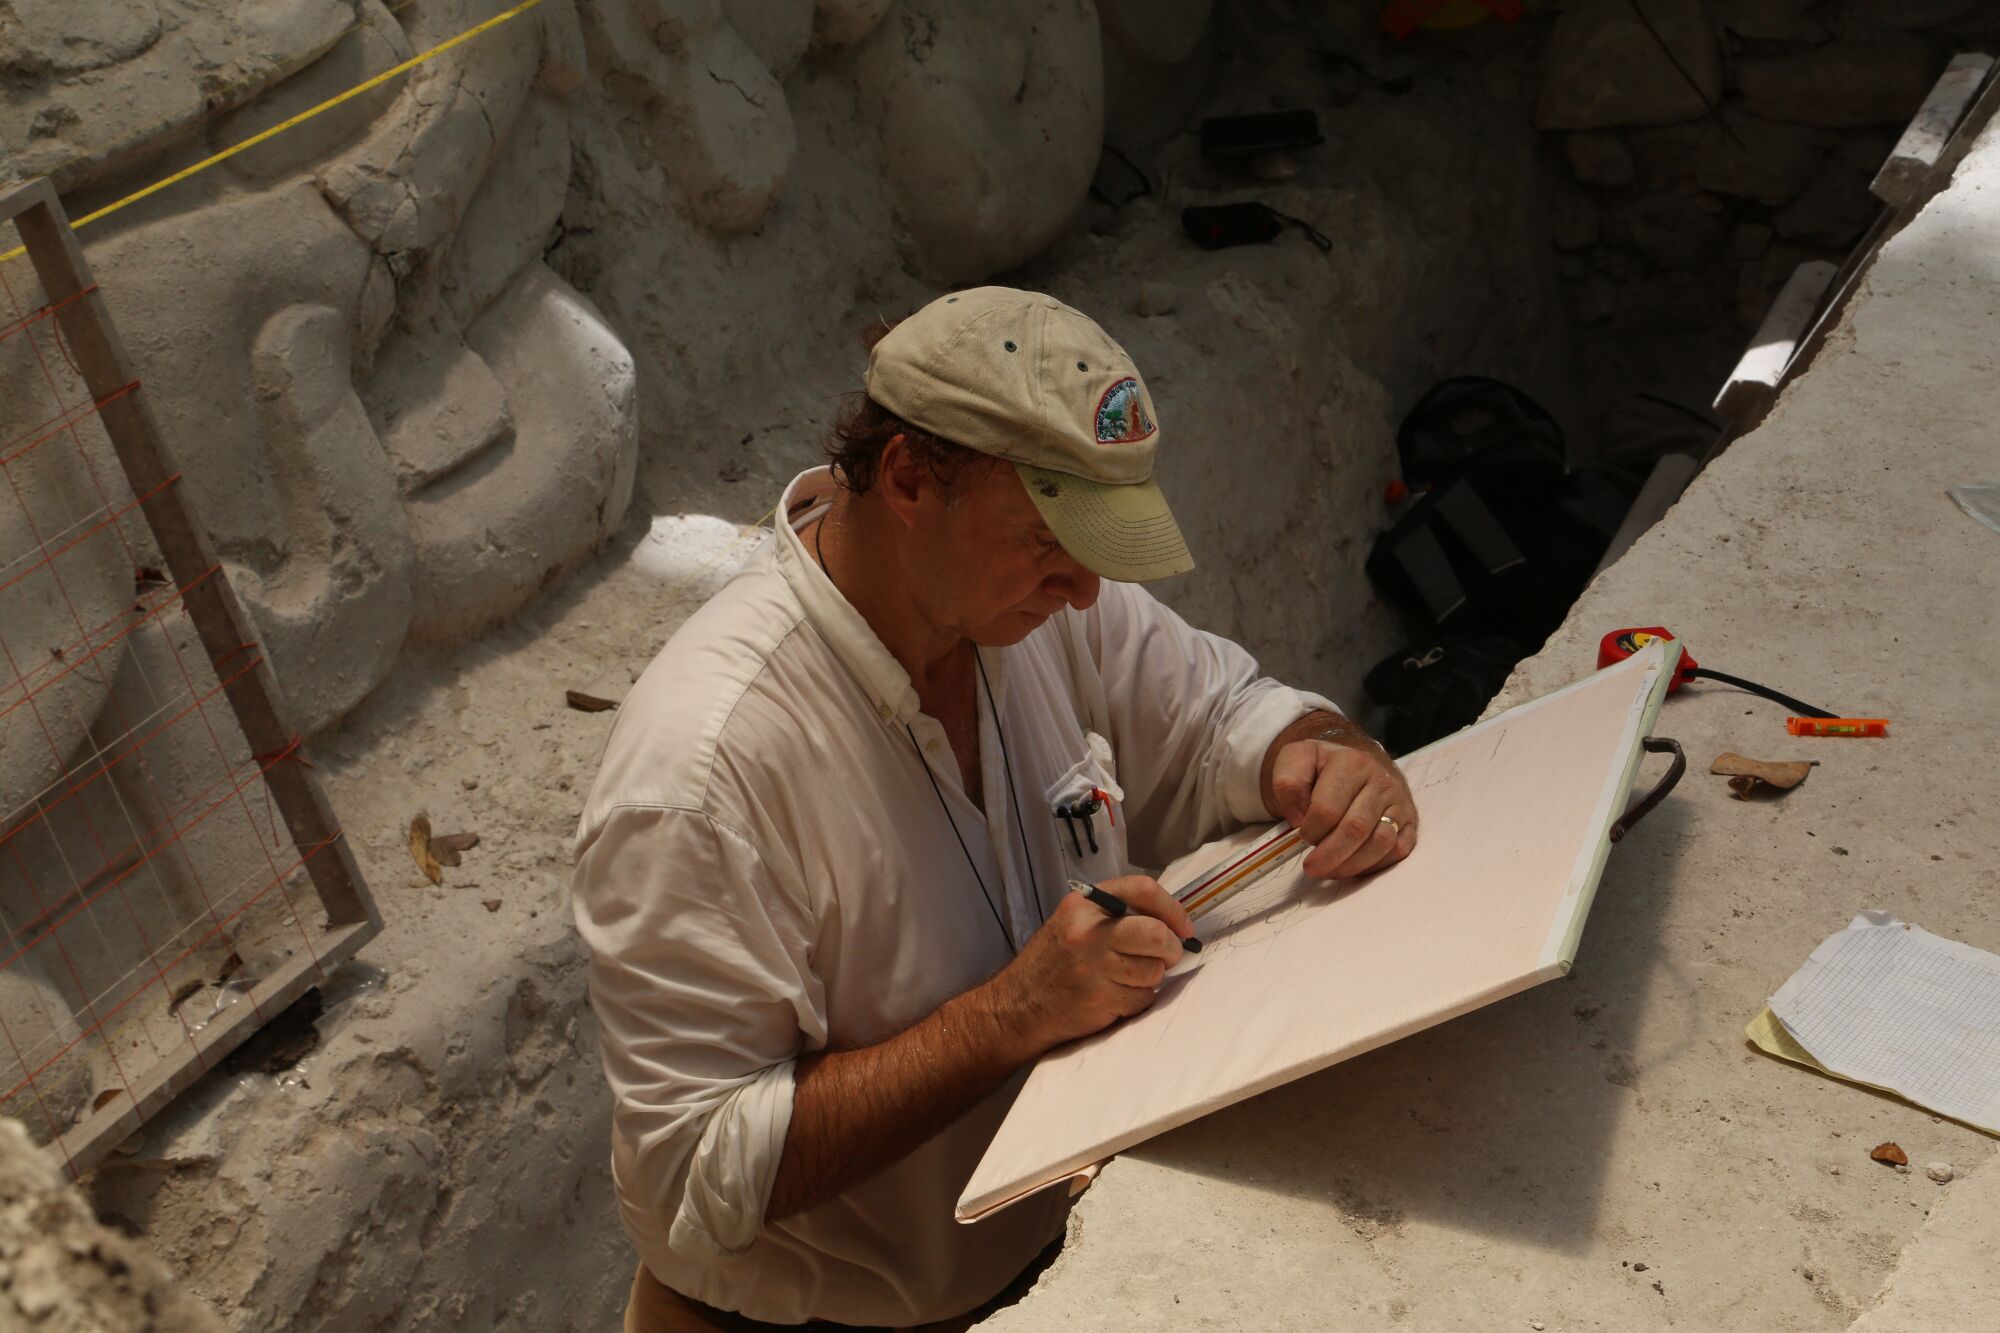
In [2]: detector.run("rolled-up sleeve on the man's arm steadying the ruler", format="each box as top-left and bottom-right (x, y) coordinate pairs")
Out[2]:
(1078, 582), (1340, 865)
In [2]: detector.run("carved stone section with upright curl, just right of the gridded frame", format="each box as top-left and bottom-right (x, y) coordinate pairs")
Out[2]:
(92, 180), (410, 729)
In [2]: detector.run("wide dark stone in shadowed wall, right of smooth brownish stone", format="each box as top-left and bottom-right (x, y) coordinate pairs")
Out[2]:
(1736, 32), (1940, 130)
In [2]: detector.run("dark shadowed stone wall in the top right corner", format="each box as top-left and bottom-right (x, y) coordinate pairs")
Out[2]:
(1536, 0), (2000, 454)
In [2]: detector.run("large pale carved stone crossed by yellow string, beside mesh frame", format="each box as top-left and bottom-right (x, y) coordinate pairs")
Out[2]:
(0, 0), (636, 731)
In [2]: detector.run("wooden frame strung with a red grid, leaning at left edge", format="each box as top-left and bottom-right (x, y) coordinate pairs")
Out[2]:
(0, 184), (380, 1173)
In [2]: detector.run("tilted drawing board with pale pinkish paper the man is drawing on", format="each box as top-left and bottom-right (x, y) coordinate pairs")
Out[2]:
(958, 640), (1668, 1221)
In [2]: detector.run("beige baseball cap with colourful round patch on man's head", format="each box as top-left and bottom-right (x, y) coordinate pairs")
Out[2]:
(866, 286), (1194, 582)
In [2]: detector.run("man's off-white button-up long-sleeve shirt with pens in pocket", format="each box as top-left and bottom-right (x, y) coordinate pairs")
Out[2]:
(574, 468), (1332, 1325)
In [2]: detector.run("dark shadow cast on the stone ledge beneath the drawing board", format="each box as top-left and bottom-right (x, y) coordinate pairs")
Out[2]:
(1130, 769), (1686, 1253)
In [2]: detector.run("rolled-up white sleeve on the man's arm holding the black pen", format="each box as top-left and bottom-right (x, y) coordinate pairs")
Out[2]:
(574, 807), (826, 1259)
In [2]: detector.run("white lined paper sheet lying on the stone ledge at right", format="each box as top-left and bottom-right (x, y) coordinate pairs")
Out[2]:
(1770, 913), (2000, 1133)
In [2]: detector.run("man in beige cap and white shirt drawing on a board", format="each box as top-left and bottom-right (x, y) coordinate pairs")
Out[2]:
(574, 288), (1416, 1333)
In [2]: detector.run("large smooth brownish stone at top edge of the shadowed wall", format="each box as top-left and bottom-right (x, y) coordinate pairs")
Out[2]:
(1534, 0), (1722, 130)
